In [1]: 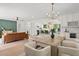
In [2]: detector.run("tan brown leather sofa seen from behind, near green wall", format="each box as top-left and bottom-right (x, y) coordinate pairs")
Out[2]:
(4, 32), (29, 43)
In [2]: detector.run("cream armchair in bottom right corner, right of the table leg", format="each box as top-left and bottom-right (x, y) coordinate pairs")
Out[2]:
(58, 46), (79, 56)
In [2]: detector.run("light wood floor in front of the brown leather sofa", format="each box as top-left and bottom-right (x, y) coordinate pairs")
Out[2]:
(0, 40), (27, 56)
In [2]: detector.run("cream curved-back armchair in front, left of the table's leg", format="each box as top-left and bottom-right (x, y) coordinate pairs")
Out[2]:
(24, 42), (51, 56)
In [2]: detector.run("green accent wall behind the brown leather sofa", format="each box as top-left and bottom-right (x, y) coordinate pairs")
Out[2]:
(0, 19), (17, 32)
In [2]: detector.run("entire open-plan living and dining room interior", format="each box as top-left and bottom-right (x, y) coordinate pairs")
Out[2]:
(0, 3), (79, 56)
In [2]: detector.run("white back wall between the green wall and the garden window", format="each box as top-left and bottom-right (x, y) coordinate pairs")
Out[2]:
(17, 18), (61, 35)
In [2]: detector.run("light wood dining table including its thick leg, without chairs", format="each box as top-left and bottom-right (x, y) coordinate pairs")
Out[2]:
(31, 35), (64, 56)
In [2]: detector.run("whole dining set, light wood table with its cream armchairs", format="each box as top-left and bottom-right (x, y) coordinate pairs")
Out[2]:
(24, 33), (79, 56)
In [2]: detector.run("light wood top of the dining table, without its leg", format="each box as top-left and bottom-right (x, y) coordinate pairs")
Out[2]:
(32, 36), (64, 46)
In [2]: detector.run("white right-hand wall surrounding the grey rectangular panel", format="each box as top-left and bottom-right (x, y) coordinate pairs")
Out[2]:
(59, 13), (79, 33)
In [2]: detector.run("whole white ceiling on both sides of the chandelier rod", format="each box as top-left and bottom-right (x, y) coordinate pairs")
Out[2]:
(0, 3), (79, 17)
